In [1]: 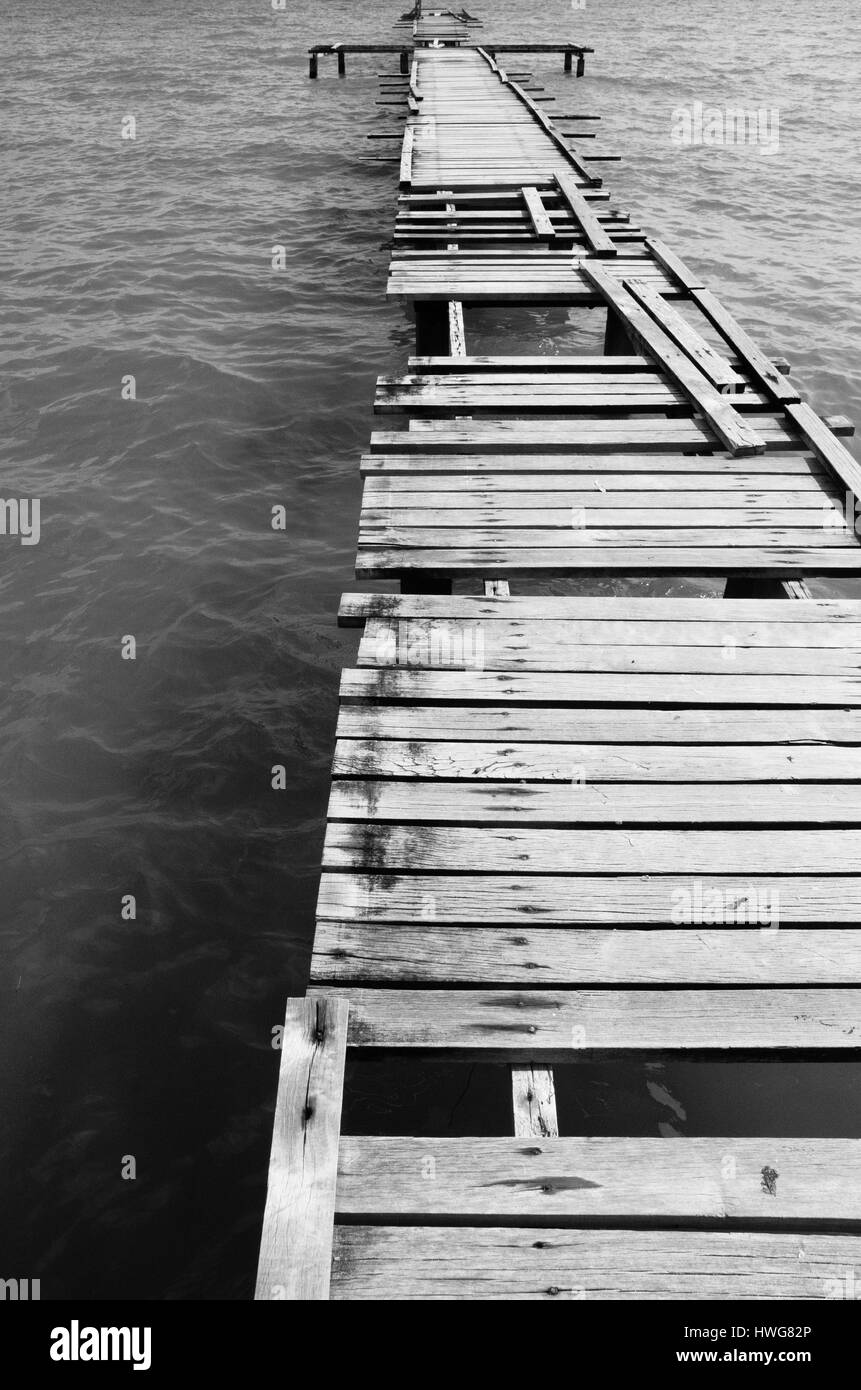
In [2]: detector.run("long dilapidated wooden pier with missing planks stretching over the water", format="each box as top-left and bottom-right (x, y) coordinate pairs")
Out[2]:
(257, 4), (861, 1300)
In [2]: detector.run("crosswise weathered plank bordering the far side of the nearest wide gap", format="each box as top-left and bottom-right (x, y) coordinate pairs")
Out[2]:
(309, 986), (861, 1062)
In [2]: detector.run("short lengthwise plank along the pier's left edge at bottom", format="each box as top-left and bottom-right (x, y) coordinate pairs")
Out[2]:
(255, 995), (349, 1301)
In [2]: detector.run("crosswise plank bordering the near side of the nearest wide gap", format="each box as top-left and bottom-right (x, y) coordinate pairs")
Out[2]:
(338, 1134), (861, 1217)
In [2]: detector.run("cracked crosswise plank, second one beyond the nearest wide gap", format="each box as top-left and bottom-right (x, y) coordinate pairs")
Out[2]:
(312, 909), (861, 987)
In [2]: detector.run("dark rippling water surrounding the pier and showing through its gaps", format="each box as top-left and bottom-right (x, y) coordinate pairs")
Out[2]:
(0, 0), (861, 1298)
